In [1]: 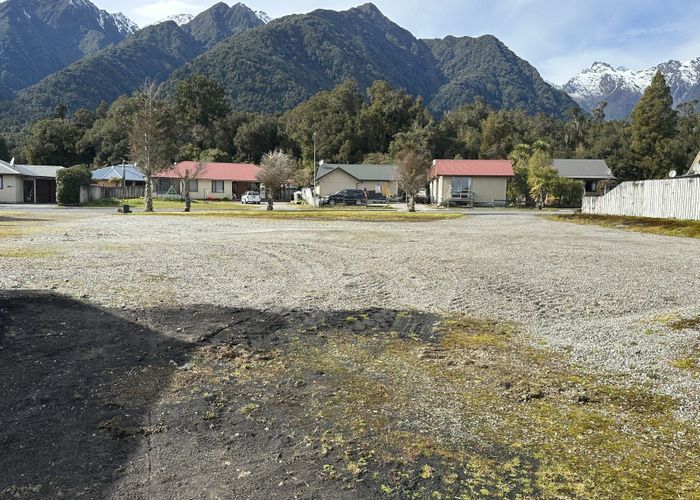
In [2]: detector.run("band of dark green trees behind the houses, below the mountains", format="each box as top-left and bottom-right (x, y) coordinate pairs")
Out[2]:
(6, 68), (700, 184)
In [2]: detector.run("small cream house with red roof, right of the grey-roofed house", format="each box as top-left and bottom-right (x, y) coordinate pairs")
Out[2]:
(429, 160), (515, 206)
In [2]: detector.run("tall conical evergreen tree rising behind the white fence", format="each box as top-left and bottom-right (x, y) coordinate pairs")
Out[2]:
(630, 71), (678, 179)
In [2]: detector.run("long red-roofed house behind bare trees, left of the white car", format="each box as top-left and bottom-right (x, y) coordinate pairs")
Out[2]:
(153, 161), (260, 200)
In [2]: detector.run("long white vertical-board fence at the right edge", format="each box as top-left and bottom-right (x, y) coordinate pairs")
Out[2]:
(581, 177), (700, 220)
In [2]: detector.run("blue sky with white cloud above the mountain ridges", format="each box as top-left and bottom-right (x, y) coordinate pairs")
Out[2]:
(93, 0), (700, 83)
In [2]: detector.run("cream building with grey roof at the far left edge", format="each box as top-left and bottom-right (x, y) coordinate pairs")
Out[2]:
(0, 160), (63, 203)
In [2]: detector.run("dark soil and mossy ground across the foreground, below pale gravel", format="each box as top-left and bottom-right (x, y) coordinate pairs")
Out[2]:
(0, 293), (700, 499)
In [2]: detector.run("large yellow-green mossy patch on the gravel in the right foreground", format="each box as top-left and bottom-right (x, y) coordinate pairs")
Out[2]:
(278, 317), (700, 498)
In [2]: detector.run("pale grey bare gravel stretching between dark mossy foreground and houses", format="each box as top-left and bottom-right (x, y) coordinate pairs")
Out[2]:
(0, 207), (700, 497)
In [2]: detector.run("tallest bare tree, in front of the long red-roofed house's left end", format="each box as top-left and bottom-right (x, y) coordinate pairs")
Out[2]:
(129, 82), (173, 212)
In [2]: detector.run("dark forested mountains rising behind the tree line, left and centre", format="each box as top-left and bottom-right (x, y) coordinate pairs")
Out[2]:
(0, 0), (576, 125)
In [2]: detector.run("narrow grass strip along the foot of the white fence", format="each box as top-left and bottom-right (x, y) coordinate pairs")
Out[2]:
(551, 214), (700, 238)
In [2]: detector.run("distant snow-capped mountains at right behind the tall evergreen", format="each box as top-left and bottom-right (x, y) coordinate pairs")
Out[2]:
(562, 58), (700, 120)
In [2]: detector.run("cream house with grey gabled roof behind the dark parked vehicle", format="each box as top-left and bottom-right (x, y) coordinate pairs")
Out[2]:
(316, 162), (399, 196)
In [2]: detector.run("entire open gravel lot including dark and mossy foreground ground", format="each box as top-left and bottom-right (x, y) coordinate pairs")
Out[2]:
(0, 207), (700, 499)
